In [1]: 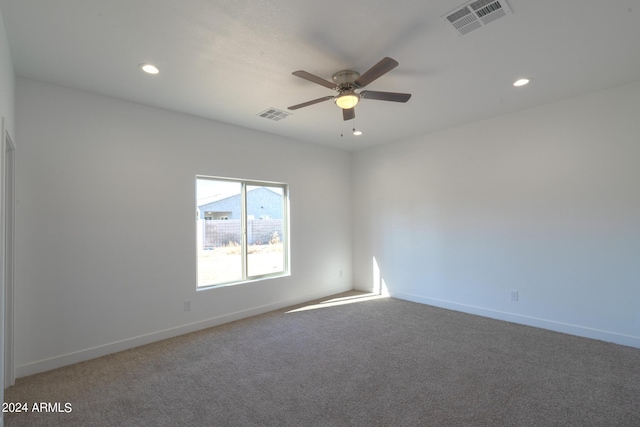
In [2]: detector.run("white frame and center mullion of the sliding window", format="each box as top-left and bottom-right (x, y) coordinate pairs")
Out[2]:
(195, 175), (291, 291)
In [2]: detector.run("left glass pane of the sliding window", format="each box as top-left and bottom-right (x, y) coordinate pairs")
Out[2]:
(196, 178), (243, 286)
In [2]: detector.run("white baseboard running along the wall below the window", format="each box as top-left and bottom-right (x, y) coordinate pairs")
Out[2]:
(15, 288), (351, 378)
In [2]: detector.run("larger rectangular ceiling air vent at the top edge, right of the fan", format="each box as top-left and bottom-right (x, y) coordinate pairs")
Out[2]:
(442, 0), (512, 36)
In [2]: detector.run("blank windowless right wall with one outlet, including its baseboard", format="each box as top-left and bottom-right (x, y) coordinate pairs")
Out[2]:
(353, 79), (640, 347)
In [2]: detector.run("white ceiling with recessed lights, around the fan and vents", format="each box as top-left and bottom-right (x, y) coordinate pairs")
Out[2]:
(0, 0), (640, 150)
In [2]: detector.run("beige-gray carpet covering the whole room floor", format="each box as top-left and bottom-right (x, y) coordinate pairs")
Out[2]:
(5, 293), (640, 427)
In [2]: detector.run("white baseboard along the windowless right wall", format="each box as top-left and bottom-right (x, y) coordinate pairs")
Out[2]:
(391, 292), (640, 348)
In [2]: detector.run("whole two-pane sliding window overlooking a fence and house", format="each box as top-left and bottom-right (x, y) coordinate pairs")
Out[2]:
(196, 176), (289, 288)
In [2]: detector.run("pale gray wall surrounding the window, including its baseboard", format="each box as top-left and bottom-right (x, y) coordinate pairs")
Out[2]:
(16, 79), (352, 375)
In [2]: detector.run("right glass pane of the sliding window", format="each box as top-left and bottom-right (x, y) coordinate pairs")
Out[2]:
(247, 185), (285, 277)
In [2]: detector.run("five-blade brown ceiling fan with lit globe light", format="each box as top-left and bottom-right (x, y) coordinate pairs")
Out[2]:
(289, 57), (411, 120)
